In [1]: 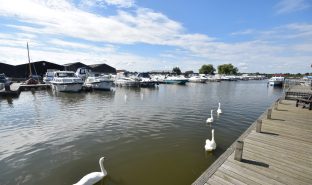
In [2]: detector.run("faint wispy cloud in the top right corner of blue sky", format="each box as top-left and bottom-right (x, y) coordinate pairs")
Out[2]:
(275, 0), (311, 14)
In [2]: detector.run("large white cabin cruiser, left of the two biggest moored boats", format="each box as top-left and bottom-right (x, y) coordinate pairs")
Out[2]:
(51, 71), (83, 92)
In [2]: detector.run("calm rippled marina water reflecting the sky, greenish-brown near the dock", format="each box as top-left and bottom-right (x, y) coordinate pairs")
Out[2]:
(0, 81), (282, 185)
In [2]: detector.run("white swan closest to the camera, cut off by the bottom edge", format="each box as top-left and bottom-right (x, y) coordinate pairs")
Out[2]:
(74, 157), (107, 185)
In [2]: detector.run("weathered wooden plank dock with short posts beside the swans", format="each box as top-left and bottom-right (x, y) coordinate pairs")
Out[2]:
(193, 100), (312, 185)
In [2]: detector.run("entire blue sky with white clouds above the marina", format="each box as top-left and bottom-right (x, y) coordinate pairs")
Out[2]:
(0, 0), (312, 73)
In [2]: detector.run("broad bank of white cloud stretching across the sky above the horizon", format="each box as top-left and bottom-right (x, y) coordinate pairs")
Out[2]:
(0, 0), (312, 72)
